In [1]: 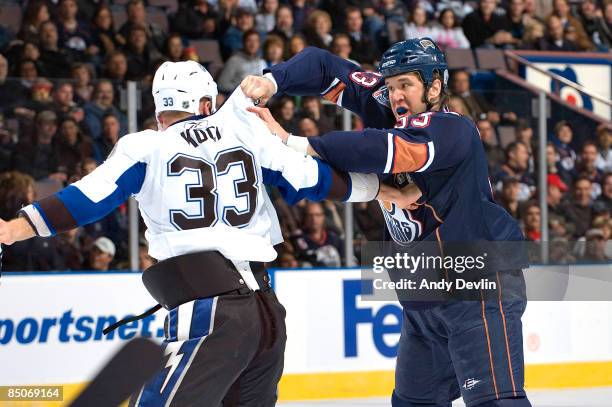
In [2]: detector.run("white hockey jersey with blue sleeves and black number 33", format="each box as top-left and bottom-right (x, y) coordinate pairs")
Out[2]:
(23, 88), (378, 268)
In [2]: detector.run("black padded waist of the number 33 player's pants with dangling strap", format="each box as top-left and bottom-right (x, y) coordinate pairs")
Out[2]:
(103, 251), (270, 335)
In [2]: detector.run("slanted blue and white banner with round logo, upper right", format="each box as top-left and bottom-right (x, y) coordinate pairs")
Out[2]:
(516, 52), (612, 120)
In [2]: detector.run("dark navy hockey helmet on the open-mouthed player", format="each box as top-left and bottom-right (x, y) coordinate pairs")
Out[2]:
(378, 37), (448, 89)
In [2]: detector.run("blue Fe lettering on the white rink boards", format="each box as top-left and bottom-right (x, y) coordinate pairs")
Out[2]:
(343, 280), (402, 358)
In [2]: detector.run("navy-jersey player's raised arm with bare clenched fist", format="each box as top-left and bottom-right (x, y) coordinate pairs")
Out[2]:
(241, 47), (382, 115)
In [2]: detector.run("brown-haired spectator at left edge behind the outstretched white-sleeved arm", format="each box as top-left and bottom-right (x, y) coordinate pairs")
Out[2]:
(0, 171), (65, 271)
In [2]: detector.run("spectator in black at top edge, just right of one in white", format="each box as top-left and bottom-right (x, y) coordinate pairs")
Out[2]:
(463, 0), (516, 48)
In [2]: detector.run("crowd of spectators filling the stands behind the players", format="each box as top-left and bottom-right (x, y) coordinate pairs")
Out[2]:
(0, 0), (612, 270)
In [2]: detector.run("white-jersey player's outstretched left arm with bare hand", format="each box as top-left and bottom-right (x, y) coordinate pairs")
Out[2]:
(0, 136), (146, 244)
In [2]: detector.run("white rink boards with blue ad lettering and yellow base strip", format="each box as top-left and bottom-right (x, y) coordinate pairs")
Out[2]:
(0, 266), (612, 405)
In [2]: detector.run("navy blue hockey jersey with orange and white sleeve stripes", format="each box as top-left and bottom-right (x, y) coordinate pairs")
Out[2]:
(269, 48), (523, 245)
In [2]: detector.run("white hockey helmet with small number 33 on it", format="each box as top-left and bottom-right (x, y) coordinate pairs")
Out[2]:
(151, 61), (218, 117)
